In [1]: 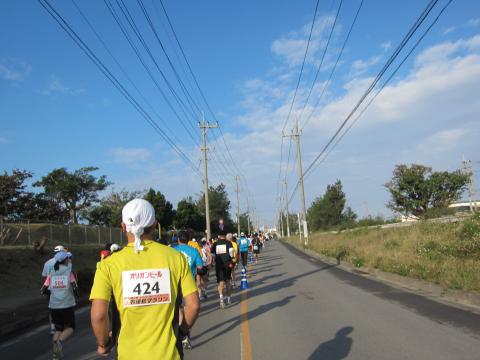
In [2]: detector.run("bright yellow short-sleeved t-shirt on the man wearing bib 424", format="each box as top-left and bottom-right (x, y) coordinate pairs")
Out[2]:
(90, 240), (197, 360)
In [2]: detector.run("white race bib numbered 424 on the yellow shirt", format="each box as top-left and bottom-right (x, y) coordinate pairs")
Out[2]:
(122, 269), (171, 308)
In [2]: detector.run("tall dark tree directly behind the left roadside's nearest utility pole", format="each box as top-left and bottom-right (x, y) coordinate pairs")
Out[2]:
(197, 184), (233, 233)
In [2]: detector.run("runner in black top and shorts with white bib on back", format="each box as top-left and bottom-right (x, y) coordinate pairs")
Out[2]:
(212, 234), (234, 309)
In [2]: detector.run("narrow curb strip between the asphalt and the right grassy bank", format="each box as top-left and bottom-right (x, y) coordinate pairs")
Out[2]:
(279, 239), (480, 314)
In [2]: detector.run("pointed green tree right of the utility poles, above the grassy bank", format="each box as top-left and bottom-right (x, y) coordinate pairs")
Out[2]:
(307, 180), (356, 231)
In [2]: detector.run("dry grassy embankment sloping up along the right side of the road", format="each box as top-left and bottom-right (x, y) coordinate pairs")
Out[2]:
(286, 214), (480, 291)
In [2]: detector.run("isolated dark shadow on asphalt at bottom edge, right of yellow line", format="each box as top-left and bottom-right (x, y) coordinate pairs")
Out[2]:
(308, 326), (353, 360)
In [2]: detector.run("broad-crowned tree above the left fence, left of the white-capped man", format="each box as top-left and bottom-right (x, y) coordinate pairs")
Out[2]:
(33, 167), (111, 224)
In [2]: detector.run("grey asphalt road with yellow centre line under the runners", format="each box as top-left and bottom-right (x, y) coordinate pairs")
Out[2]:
(0, 242), (480, 360)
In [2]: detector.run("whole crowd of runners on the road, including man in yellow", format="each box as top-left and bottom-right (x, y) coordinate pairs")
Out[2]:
(41, 199), (272, 359)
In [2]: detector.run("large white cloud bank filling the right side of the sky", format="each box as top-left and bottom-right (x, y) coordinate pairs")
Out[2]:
(226, 35), (480, 217)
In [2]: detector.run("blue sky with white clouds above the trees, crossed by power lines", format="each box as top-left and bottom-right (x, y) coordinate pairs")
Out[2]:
(0, 0), (480, 224)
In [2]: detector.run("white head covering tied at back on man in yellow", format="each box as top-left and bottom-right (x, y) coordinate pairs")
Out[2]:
(122, 199), (155, 253)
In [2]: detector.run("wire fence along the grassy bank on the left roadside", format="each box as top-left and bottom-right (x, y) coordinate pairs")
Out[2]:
(0, 218), (127, 246)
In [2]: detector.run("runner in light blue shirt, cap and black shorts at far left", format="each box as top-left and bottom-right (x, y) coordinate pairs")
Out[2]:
(42, 251), (78, 359)
